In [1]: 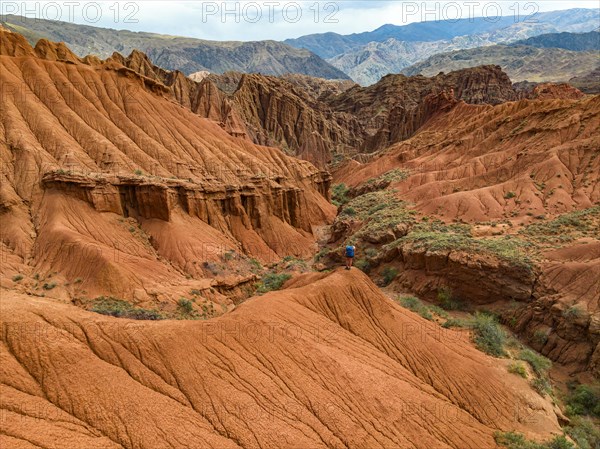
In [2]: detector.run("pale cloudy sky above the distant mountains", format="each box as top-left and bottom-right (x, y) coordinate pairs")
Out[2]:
(0, 0), (598, 41)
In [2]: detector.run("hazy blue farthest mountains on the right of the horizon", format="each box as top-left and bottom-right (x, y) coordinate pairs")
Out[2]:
(314, 9), (600, 85)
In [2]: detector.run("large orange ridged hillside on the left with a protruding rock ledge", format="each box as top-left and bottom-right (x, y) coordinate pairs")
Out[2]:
(0, 30), (335, 299)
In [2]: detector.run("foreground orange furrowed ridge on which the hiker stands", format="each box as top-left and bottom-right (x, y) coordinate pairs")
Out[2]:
(0, 270), (559, 449)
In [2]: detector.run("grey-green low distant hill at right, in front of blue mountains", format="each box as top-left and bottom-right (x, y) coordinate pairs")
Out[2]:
(402, 45), (600, 82)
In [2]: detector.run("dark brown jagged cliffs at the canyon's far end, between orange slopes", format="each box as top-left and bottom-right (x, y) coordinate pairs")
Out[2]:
(203, 66), (518, 166)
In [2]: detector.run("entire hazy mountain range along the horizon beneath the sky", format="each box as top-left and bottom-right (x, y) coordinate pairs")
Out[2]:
(2, 8), (600, 86)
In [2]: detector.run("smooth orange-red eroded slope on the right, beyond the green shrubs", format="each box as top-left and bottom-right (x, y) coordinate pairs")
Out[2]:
(336, 96), (600, 222)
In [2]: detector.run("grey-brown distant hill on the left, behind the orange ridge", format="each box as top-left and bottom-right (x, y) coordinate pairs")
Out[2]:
(0, 15), (349, 79)
